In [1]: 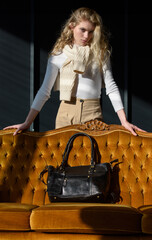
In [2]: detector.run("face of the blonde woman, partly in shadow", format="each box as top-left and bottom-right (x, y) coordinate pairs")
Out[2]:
(71, 20), (95, 46)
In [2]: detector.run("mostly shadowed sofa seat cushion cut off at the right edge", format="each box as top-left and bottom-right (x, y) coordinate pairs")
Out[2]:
(138, 205), (152, 234)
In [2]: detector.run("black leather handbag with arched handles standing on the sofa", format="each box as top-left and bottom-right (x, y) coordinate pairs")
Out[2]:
(40, 132), (118, 203)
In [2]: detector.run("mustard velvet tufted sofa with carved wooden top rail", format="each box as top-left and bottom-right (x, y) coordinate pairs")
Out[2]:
(0, 121), (152, 240)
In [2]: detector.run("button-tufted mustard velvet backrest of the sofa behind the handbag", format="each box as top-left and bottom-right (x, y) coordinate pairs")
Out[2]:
(0, 125), (152, 207)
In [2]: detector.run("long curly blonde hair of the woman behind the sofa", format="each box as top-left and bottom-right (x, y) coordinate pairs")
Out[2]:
(49, 7), (110, 70)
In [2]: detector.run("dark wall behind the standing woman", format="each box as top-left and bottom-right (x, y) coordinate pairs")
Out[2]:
(0, 0), (152, 132)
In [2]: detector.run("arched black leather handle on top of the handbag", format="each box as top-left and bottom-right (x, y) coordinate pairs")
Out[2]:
(60, 132), (95, 170)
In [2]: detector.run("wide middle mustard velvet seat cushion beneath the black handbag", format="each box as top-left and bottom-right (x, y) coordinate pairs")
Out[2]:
(30, 203), (142, 234)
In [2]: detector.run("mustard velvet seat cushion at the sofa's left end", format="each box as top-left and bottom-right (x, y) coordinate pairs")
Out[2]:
(0, 203), (37, 231)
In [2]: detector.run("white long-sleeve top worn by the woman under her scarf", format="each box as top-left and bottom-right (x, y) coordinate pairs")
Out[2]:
(31, 53), (123, 112)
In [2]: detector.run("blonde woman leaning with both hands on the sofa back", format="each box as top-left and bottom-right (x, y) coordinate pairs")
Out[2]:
(5, 8), (144, 135)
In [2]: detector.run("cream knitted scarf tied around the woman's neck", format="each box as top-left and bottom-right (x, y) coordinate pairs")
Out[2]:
(54, 45), (90, 101)
